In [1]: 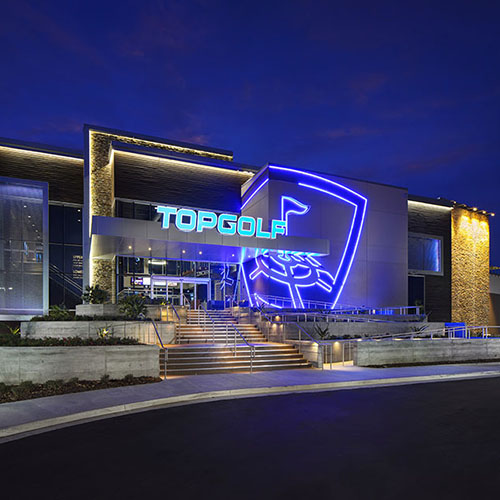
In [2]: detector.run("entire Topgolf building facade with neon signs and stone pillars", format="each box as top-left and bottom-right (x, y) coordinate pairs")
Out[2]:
(0, 126), (491, 324)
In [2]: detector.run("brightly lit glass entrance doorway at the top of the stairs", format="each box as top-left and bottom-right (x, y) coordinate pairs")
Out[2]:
(151, 275), (211, 309)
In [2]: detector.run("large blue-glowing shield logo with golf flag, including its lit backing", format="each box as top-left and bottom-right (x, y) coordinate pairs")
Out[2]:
(241, 165), (368, 309)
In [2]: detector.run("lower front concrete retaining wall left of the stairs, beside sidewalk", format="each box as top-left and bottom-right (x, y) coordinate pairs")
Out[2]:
(0, 345), (159, 384)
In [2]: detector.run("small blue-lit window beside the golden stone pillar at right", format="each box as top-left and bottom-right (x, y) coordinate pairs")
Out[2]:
(408, 233), (443, 275)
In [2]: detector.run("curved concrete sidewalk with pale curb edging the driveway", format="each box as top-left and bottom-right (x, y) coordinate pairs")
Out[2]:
(0, 363), (500, 442)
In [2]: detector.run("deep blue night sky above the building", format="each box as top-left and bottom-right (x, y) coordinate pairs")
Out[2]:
(0, 0), (500, 265)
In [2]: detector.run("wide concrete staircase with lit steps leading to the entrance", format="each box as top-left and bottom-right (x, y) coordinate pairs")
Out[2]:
(160, 310), (311, 376)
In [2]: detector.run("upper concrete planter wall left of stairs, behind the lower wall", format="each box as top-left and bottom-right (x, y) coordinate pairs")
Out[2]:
(21, 321), (175, 344)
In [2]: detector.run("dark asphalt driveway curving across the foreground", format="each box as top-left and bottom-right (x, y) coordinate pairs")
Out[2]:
(0, 378), (500, 500)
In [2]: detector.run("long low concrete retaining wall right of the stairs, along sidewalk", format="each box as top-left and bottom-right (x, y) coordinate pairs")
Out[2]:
(354, 338), (500, 366)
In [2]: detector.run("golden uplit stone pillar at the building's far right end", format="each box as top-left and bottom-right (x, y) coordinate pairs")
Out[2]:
(451, 208), (490, 325)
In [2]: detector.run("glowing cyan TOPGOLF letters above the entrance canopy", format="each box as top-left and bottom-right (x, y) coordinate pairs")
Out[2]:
(156, 206), (286, 240)
